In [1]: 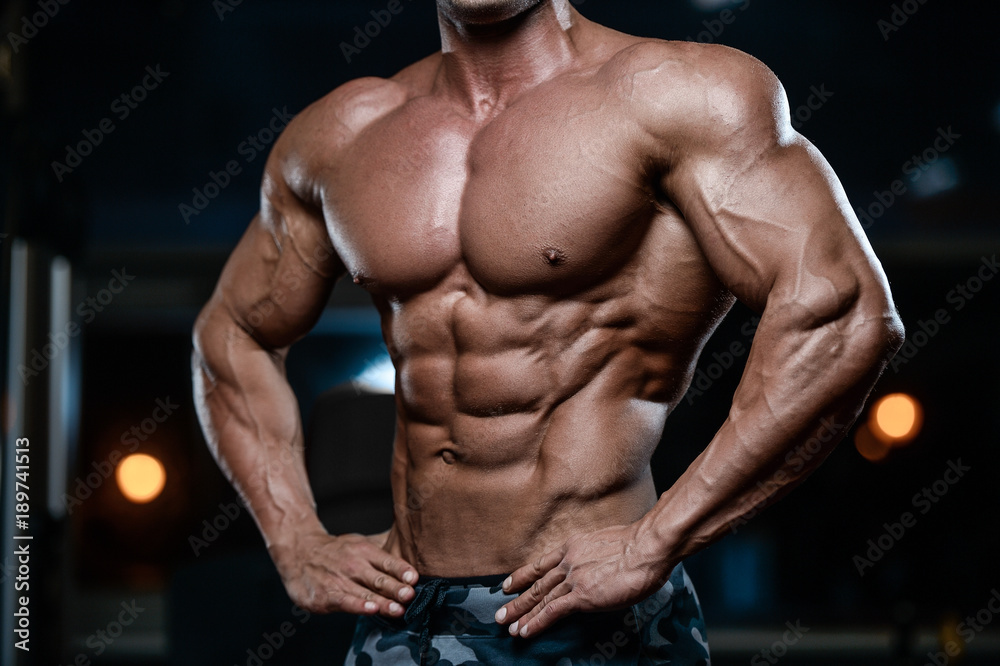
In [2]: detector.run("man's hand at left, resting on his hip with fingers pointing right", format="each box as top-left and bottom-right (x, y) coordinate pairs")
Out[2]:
(272, 531), (418, 617)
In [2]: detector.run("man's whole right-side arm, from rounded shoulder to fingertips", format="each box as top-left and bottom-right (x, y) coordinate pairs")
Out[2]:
(497, 46), (902, 636)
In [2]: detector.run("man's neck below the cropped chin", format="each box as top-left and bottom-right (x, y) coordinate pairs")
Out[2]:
(438, 0), (580, 115)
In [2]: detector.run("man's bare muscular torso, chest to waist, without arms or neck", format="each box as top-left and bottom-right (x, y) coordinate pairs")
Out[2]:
(313, 37), (732, 576)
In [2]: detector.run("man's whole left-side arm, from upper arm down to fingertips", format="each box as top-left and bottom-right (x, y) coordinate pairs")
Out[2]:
(192, 116), (416, 615)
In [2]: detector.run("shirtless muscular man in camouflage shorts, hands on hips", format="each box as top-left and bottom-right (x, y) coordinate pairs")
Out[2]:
(193, 0), (902, 664)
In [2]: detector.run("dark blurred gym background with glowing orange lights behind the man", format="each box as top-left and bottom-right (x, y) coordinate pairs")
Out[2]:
(0, 0), (1000, 666)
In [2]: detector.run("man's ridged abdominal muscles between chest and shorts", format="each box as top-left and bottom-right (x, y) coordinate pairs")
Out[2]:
(383, 272), (683, 576)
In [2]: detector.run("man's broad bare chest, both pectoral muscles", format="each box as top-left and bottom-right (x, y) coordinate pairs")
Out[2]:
(324, 89), (653, 295)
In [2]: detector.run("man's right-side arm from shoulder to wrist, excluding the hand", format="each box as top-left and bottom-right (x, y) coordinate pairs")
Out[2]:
(643, 45), (902, 564)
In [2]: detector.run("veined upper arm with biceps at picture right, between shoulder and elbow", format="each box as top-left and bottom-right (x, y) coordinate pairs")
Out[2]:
(672, 137), (879, 320)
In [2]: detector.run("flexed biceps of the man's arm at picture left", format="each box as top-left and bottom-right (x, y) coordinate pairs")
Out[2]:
(216, 212), (343, 349)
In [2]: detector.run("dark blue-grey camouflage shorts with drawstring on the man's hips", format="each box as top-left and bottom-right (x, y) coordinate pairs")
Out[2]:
(345, 565), (710, 666)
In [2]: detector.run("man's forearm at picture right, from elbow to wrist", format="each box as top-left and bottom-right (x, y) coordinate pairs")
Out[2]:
(640, 298), (899, 565)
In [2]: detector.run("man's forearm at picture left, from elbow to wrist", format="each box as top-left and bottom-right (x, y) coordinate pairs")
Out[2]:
(192, 304), (322, 555)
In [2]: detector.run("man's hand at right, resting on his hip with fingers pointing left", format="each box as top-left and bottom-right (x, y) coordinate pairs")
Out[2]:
(496, 525), (670, 637)
